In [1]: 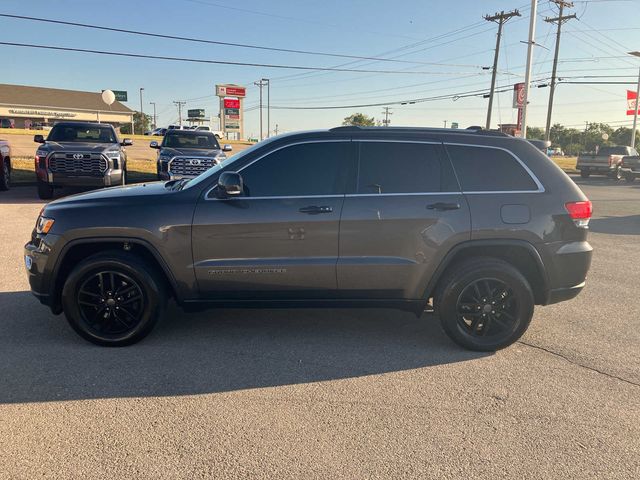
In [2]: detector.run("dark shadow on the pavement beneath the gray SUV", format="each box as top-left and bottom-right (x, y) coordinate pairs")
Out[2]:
(0, 292), (487, 404)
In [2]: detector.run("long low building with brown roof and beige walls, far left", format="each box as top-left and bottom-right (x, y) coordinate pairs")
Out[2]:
(0, 84), (134, 129)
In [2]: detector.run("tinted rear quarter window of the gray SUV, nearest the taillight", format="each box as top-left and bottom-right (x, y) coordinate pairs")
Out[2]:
(447, 145), (538, 192)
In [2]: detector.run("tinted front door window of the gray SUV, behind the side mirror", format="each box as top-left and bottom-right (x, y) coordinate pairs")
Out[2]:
(240, 142), (350, 197)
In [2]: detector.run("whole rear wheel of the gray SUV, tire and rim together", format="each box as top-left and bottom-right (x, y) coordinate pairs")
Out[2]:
(435, 257), (534, 352)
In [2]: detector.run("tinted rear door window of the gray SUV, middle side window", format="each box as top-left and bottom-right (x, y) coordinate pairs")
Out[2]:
(357, 142), (458, 193)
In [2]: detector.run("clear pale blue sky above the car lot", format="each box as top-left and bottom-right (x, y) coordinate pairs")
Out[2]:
(0, 0), (640, 136)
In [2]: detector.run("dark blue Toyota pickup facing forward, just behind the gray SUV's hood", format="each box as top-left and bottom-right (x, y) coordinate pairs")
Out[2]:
(149, 130), (232, 180)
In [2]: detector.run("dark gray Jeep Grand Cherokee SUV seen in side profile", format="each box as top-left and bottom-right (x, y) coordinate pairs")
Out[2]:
(25, 127), (592, 351)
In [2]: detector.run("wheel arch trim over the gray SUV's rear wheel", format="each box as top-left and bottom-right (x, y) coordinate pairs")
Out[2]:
(423, 239), (549, 305)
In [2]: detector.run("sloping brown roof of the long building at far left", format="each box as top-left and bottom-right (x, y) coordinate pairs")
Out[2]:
(0, 84), (133, 113)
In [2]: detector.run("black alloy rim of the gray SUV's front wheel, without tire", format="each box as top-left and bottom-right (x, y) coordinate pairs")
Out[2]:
(76, 270), (146, 337)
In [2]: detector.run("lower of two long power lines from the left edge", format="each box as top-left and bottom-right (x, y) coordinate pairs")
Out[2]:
(0, 42), (457, 75)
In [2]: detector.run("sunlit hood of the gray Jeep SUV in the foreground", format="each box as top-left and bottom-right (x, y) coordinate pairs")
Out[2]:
(45, 182), (174, 212)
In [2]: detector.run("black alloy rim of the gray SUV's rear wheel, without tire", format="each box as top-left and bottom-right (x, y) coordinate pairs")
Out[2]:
(457, 278), (518, 339)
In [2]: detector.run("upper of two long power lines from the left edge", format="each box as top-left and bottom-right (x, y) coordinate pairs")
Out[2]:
(0, 13), (477, 67)
